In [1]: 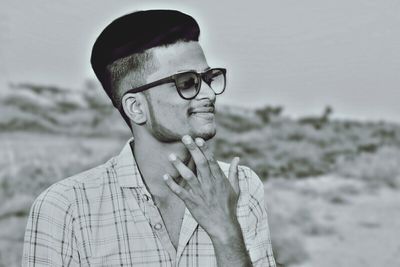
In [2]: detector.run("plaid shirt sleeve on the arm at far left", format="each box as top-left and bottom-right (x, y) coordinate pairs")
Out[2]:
(22, 184), (80, 266)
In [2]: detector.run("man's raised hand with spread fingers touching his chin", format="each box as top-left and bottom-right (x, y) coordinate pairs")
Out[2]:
(164, 136), (240, 242)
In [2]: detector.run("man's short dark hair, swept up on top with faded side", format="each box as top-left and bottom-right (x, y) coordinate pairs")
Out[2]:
(91, 10), (200, 114)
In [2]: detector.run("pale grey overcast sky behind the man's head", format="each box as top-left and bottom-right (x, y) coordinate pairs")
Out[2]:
(0, 0), (400, 122)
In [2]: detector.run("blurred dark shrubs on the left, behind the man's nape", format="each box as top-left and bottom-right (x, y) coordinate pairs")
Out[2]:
(0, 83), (130, 137)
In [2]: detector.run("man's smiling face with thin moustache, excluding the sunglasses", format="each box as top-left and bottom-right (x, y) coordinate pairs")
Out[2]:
(140, 42), (216, 142)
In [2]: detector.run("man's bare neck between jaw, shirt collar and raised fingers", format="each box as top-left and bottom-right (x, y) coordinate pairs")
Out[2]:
(132, 131), (195, 199)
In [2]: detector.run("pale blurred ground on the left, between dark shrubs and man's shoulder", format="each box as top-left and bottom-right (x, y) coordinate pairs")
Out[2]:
(0, 136), (124, 202)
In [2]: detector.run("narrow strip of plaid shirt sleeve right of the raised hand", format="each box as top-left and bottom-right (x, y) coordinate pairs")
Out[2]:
(246, 168), (276, 267)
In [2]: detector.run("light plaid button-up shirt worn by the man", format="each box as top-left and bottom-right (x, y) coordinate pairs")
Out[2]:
(22, 139), (275, 267)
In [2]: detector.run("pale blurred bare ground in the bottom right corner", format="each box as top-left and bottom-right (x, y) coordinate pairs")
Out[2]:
(302, 189), (400, 267)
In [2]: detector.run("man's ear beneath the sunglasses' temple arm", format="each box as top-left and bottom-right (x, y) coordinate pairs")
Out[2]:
(121, 94), (147, 125)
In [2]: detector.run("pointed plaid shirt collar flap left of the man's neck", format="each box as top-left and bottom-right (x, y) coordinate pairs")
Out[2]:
(114, 137), (144, 187)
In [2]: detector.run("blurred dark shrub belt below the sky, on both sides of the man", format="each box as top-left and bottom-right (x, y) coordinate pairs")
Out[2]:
(0, 81), (400, 182)
